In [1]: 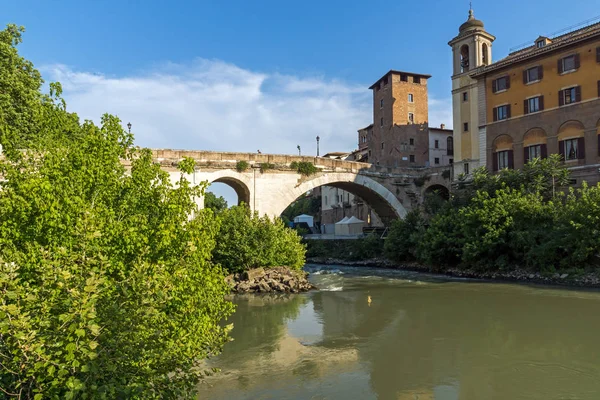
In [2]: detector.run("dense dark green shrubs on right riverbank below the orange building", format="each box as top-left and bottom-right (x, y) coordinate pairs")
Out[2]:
(386, 156), (600, 271)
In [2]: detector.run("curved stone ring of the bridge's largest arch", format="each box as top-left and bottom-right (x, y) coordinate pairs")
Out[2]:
(268, 173), (407, 224)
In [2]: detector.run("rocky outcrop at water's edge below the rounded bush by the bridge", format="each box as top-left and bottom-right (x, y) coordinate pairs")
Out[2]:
(226, 267), (314, 293)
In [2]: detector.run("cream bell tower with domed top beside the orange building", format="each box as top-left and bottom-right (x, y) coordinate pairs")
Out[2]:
(448, 9), (496, 179)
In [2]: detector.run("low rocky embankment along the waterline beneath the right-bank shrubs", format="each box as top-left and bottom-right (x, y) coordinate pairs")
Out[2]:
(306, 257), (600, 287)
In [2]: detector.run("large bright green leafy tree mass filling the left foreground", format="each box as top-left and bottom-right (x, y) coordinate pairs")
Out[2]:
(0, 26), (233, 399)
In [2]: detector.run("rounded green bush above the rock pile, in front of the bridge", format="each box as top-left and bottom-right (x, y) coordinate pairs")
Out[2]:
(213, 206), (306, 273)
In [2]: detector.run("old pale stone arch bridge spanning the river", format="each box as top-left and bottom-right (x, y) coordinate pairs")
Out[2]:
(145, 149), (450, 224)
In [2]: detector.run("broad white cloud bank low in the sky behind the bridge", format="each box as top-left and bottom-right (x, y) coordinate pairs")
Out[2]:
(42, 59), (451, 155)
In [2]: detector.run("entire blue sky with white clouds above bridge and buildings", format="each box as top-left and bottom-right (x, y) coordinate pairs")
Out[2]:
(1, 0), (600, 203)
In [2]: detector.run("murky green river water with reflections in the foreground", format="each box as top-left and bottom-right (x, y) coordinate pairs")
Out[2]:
(199, 265), (600, 400)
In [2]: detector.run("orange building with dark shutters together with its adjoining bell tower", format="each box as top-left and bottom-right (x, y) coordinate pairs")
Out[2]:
(450, 11), (600, 184)
